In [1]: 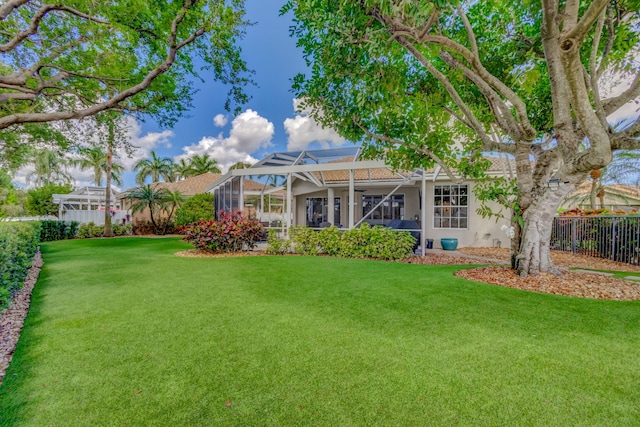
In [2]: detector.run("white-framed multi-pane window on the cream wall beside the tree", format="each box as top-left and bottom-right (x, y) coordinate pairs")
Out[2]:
(433, 185), (469, 228)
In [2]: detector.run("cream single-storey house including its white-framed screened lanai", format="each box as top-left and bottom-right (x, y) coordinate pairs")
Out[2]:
(208, 147), (509, 247)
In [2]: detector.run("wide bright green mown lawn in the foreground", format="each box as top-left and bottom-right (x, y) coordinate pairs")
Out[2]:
(0, 238), (640, 427)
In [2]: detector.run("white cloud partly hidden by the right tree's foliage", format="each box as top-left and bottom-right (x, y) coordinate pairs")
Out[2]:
(284, 99), (346, 151)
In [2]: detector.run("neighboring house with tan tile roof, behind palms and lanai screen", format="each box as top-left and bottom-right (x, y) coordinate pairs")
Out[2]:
(118, 172), (282, 223)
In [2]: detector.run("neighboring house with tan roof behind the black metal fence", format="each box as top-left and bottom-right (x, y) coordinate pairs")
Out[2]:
(559, 181), (640, 212)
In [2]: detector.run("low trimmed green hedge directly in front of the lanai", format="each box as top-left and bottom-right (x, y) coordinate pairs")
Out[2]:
(291, 224), (415, 260)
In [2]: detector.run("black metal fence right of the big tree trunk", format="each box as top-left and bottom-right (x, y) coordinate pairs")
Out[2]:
(551, 216), (640, 265)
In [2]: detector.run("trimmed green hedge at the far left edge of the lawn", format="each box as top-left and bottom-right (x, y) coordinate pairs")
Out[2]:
(0, 222), (41, 310)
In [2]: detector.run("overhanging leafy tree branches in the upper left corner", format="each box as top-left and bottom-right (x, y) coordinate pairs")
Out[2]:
(0, 0), (250, 131)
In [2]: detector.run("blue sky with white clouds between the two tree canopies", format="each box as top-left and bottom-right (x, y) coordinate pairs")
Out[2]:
(111, 0), (346, 187)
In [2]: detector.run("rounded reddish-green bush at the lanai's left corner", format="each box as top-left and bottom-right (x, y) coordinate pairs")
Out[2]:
(181, 212), (265, 253)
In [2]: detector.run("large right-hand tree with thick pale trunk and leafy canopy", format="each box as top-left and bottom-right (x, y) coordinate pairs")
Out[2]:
(282, 0), (640, 275)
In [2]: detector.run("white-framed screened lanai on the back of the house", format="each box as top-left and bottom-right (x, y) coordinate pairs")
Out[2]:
(208, 147), (437, 247)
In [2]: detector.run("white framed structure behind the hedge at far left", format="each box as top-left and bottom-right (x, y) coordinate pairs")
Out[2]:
(53, 187), (131, 225)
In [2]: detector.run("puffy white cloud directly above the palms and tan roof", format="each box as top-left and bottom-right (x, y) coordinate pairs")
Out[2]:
(176, 109), (275, 172)
